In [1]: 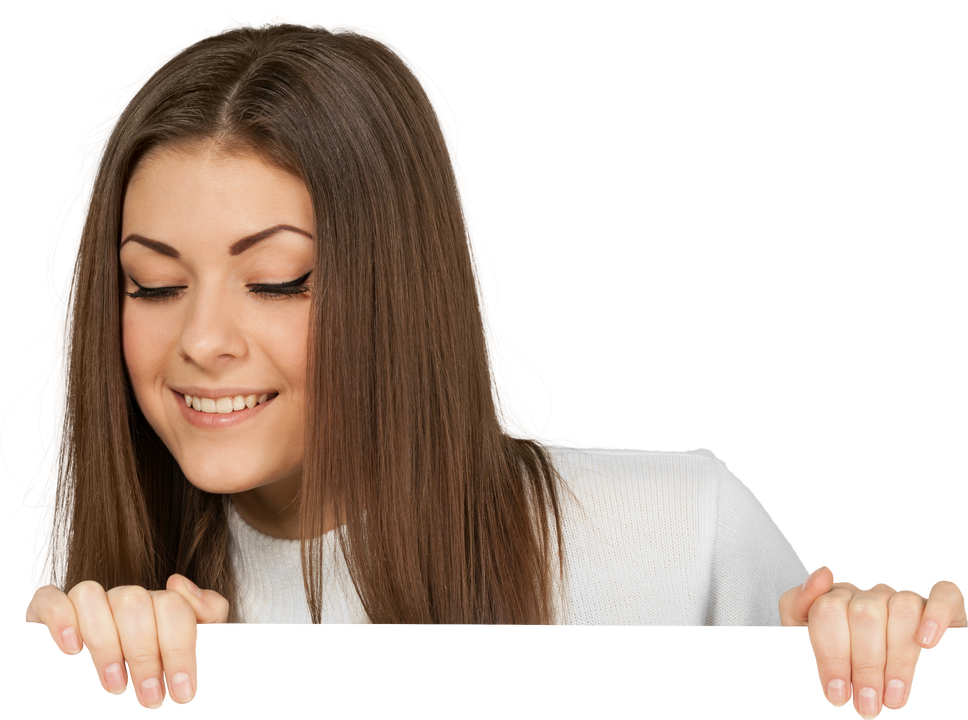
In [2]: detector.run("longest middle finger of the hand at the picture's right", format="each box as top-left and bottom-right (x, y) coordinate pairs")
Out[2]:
(847, 582), (897, 719)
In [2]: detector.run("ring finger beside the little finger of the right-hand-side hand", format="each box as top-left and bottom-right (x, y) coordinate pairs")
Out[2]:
(884, 588), (925, 710)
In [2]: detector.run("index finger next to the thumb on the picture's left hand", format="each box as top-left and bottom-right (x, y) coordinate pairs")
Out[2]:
(151, 591), (199, 707)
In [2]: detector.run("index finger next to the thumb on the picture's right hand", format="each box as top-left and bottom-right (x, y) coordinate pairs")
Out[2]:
(806, 588), (851, 710)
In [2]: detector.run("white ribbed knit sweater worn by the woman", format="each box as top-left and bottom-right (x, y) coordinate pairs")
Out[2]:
(226, 441), (810, 629)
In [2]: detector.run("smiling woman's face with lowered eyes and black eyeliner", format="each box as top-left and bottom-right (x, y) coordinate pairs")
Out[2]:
(119, 150), (316, 537)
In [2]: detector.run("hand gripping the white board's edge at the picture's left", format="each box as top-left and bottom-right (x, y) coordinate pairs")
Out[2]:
(23, 575), (229, 710)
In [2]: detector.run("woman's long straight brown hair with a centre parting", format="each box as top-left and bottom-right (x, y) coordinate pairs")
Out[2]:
(32, 16), (565, 627)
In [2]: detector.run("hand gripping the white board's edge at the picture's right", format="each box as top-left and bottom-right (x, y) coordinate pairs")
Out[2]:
(780, 563), (968, 718)
